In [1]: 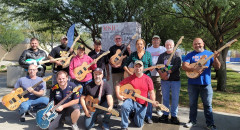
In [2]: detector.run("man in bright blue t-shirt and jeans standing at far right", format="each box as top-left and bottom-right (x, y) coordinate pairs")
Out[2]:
(182, 38), (221, 130)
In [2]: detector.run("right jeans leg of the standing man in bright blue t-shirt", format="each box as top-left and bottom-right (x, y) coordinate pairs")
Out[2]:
(200, 84), (214, 126)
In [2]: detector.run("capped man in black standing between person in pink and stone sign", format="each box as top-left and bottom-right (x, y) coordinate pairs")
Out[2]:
(88, 40), (110, 81)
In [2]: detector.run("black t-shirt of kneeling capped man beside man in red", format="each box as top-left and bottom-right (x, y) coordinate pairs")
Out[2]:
(82, 81), (113, 104)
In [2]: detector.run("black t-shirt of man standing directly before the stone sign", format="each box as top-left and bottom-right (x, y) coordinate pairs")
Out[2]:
(108, 44), (129, 73)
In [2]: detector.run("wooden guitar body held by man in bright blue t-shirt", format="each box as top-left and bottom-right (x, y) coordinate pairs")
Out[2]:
(186, 55), (207, 79)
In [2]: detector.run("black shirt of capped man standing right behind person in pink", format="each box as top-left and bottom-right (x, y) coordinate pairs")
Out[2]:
(88, 50), (108, 76)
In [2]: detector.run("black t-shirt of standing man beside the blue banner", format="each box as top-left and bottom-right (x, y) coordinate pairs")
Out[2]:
(49, 45), (70, 72)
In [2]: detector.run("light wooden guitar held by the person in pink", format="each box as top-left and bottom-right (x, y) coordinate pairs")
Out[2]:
(73, 51), (110, 81)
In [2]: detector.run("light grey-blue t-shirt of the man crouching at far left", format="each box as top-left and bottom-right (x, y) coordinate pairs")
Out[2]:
(14, 76), (46, 100)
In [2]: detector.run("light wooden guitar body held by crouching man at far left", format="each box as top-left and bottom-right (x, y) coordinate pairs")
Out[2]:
(2, 88), (28, 111)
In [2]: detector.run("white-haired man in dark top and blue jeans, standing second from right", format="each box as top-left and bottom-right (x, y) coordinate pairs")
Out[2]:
(156, 39), (181, 124)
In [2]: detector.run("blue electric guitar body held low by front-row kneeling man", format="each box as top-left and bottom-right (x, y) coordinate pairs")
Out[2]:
(36, 101), (58, 129)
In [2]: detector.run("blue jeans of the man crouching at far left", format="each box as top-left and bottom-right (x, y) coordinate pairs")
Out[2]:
(19, 97), (49, 115)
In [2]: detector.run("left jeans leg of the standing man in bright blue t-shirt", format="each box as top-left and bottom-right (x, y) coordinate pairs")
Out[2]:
(188, 84), (200, 123)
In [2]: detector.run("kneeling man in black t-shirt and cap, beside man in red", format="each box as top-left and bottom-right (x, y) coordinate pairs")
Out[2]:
(80, 68), (113, 130)
